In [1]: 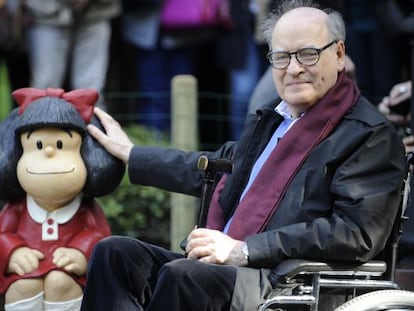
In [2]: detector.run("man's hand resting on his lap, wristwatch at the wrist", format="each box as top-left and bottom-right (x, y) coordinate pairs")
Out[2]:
(186, 228), (247, 266)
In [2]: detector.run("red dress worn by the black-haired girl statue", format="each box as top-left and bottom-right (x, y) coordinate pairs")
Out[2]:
(0, 199), (111, 293)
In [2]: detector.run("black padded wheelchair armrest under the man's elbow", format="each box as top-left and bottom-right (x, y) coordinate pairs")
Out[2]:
(271, 259), (387, 281)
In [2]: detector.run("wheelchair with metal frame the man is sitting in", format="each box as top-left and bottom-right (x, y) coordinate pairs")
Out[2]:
(258, 153), (414, 311)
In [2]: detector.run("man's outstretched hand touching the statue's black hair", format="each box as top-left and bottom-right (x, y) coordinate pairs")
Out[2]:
(88, 107), (134, 164)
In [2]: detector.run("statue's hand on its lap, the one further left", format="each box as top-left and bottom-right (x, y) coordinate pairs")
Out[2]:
(7, 247), (45, 276)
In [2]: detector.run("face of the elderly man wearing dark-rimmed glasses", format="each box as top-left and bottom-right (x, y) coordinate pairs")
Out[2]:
(271, 8), (345, 117)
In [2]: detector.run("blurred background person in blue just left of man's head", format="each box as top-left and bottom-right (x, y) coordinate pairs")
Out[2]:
(222, 0), (273, 140)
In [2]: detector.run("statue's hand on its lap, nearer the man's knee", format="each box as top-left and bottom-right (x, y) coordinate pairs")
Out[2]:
(53, 247), (88, 276)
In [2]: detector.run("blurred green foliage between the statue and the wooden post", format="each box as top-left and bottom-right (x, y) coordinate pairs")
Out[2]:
(97, 125), (170, 247)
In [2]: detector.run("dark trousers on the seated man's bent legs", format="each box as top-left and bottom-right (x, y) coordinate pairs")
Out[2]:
(81, 236), (236, 311)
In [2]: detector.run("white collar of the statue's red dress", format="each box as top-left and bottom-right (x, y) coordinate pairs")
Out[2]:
(26, 195), (82, 224)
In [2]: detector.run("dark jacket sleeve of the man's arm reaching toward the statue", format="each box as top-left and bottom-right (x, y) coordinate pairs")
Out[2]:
(128, 142), (235, 196)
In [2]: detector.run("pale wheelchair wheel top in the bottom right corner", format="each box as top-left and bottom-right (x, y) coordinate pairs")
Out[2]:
(335, 290), (414, 311)
